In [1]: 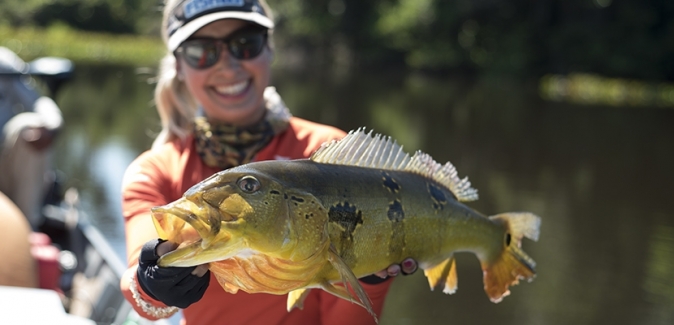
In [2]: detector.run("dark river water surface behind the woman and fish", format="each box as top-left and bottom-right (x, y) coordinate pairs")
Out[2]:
(50, 67), (674, 324)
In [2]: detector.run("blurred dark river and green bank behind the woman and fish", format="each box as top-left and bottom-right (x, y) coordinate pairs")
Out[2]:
(0, 0), (674, 325)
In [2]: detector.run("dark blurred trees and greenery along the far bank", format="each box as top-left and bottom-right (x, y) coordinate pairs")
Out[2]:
(0, 0), (674, 80)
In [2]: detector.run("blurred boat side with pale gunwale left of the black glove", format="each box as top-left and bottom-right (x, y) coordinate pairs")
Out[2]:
(41, 188), (170, 325)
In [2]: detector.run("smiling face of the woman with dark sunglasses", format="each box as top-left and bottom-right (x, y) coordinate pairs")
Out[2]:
(176, 19), (272, 126)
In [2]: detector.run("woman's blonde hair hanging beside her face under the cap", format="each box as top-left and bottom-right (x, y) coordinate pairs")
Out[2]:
(152, 0), (274, 149)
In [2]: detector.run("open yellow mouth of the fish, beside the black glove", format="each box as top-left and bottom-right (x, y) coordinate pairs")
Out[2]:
(151, 197), (238, 267)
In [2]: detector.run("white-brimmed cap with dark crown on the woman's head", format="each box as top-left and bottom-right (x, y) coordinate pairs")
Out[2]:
(166, 0), (274, 52)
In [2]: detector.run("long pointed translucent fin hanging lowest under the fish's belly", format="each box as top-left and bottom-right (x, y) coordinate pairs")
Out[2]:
(321, 245), (377, 320)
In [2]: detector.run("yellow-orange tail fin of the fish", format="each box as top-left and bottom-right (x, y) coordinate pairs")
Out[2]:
(482, 213), (541, 303)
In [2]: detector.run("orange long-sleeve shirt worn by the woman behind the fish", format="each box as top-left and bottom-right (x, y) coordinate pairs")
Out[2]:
(121, 117), (391, 325)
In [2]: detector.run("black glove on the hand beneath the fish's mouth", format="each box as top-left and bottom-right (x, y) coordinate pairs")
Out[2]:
(136, 239), (211, 308)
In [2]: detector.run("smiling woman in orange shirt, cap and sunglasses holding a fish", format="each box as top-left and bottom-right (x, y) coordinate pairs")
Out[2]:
(121, 0), (416, 324)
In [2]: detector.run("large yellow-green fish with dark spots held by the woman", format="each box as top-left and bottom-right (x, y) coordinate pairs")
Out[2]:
(152, 128), (541, 319)
